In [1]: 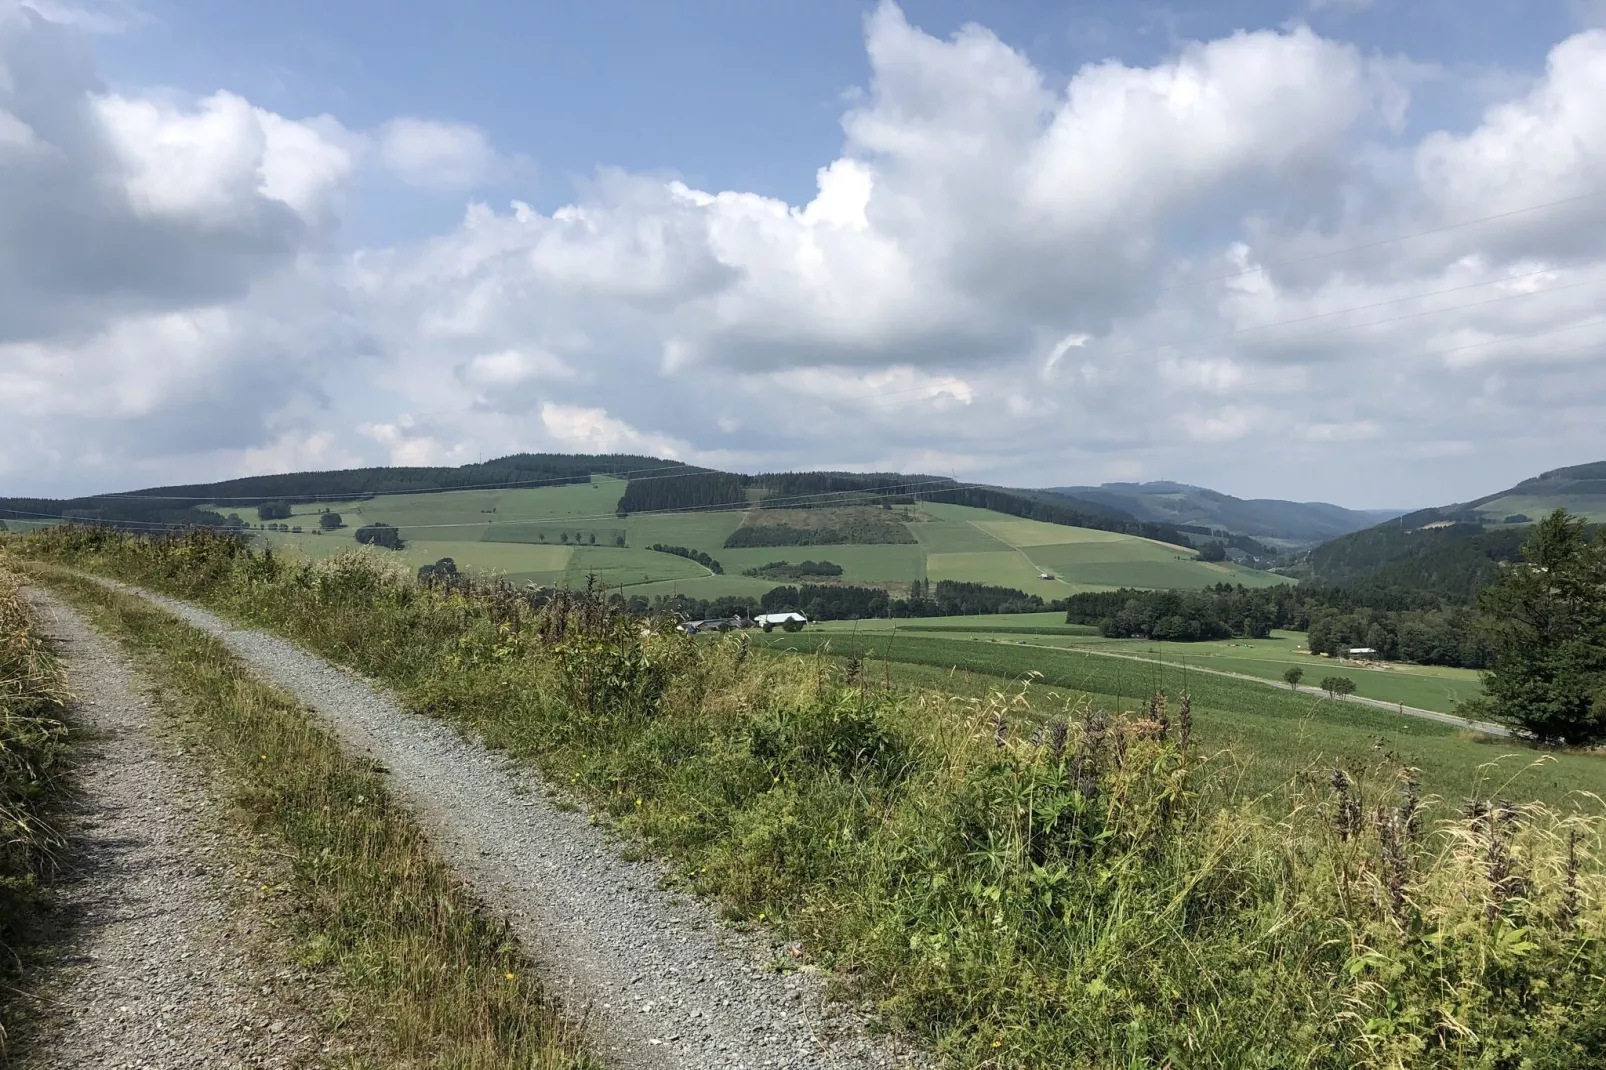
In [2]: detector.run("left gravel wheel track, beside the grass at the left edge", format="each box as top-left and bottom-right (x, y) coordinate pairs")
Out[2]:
(18, 591), (321, 1070)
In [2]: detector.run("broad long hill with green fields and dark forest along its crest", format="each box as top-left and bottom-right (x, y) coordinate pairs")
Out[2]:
(0, 455), (1286, 601)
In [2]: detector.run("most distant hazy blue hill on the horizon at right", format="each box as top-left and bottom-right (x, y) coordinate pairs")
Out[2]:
(1050, 482), (1397, 546)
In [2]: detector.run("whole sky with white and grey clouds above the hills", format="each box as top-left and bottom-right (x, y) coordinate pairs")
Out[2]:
(0, 0), (1606, 506)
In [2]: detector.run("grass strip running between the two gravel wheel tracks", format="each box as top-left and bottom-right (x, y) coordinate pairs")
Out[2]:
(25, 569), (589, 1070)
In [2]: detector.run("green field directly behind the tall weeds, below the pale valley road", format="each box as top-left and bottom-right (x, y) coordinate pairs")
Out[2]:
(753, 622), (1606, 808)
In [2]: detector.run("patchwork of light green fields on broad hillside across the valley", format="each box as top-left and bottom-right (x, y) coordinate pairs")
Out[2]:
(232, 476), (1285, 601)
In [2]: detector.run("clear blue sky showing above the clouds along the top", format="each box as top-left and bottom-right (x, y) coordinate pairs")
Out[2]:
(98, 0), (1587, 218)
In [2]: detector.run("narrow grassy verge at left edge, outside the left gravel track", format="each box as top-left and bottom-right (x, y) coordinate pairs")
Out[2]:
(0, 561), (71, 1047)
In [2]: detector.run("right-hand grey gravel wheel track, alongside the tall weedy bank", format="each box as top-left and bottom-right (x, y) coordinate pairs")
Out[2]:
(91, 585), (930, 1070)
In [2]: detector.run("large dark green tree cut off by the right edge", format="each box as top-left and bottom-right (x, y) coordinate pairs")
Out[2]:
(1468, 509), (1606, 745)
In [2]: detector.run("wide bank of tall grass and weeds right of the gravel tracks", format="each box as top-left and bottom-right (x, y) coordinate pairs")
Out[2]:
(12, 529), (1606, 1070)
